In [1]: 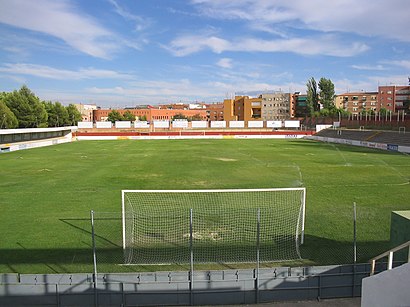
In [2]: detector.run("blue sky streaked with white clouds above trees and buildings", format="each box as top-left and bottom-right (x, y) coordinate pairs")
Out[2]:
(0, 0), (410, 107)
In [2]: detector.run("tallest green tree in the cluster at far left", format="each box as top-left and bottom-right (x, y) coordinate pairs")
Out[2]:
(5, 85), (47, 128)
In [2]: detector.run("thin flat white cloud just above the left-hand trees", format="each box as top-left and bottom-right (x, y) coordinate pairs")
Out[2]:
(0, 63), (132, 80)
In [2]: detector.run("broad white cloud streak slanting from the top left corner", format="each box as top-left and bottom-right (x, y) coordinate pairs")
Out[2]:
(0, 0), (119, 58)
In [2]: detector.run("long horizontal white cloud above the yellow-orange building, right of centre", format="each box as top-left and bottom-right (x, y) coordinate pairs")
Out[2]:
(167, 35), (369, 57)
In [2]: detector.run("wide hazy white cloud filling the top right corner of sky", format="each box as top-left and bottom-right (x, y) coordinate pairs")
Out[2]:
(191, 0), (410, 42)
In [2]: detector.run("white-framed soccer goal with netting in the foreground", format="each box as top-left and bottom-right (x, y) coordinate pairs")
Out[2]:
(122, 188), (306, 264)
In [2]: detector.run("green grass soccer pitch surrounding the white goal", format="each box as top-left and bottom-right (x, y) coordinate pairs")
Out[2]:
(0, 139), (410, 273)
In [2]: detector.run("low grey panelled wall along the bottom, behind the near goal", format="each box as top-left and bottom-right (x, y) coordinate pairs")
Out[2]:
(0, 264), (370, 306)
